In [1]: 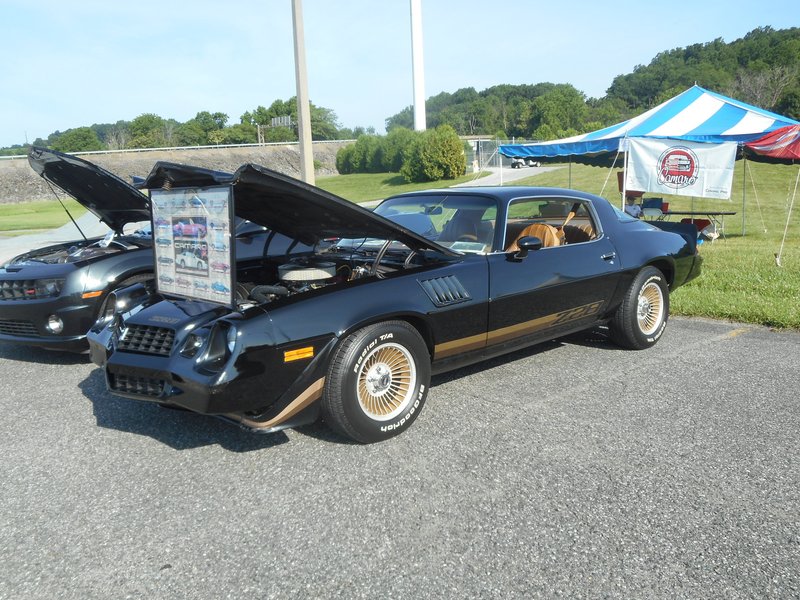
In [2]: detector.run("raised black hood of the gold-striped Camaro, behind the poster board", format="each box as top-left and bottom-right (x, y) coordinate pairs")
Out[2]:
(142, 162), (457, 255)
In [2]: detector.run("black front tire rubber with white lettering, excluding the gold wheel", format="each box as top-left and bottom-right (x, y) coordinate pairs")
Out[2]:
(332, 323), (430, 442)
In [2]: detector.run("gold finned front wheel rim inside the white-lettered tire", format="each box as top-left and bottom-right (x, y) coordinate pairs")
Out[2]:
(357, 343), (417, 421)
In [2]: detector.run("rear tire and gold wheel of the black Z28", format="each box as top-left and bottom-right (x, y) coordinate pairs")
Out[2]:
(609, 267), (669, 350)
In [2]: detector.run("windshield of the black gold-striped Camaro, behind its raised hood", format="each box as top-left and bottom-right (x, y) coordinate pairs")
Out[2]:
(375, 193), (497, 252)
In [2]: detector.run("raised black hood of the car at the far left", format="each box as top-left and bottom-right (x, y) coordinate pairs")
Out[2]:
(28, 146), (150, 233)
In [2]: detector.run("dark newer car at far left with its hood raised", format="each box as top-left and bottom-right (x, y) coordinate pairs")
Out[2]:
(0, 147), (153, 350)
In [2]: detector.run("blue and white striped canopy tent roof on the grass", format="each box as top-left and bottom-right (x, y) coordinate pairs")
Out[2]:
(499, 85), (798, 164)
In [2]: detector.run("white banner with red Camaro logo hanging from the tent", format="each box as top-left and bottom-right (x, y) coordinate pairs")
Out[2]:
(625, 138), (736, 200)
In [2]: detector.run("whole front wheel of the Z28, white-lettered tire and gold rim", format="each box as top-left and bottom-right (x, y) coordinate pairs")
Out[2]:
(322, 321), (431, 443)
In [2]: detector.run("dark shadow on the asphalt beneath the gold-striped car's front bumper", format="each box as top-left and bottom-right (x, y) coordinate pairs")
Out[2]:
(78, 369), (289, 452)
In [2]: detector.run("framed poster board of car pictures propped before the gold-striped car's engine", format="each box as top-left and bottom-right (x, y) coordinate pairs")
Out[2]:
(150, 186), (236, 307)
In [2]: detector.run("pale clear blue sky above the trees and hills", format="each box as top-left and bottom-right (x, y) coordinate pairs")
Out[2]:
(0, 0), (800, 146)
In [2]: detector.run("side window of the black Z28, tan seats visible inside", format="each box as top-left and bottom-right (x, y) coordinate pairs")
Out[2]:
(505, 198), (598, 252)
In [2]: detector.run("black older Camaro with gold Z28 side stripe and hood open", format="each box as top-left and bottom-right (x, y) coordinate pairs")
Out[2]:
(89, 163), (701, 442)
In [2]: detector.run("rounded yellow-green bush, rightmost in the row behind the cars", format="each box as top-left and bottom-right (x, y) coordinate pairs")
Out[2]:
(400, 125), (467, 182)
